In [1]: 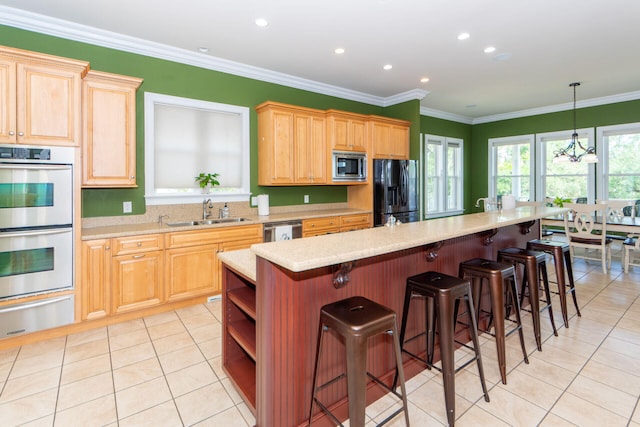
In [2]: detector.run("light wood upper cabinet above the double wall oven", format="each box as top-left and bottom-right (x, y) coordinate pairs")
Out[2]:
(0, 46), (89, 146)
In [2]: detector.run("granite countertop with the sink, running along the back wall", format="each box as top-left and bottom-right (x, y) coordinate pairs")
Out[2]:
(81, 208), (371, 240)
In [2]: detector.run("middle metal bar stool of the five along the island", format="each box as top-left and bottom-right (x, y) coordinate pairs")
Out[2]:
(459, 258), (529, 384)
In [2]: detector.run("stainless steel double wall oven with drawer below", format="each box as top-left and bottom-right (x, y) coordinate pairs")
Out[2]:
(0, 145), (75, 337)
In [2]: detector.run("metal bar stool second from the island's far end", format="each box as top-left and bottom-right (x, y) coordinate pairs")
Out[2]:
(498, 248), (558, 351)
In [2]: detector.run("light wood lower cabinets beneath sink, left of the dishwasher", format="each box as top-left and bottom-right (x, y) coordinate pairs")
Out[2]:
(80, 224), (262, 320)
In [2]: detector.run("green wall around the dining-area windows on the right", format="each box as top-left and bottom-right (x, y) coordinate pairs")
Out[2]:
(465, 100), (640, 210)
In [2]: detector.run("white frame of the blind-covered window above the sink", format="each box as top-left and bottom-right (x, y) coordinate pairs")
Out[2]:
(144, 92), (251, 205)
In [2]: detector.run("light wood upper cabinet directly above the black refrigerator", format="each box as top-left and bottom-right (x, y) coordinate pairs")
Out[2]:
(369, 116), (410, 160)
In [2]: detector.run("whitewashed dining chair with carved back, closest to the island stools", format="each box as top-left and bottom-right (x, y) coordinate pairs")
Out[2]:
(563, 203), (612, 274)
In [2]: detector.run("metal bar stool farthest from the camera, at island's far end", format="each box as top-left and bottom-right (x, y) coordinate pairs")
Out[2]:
(527, 239), (581, 328)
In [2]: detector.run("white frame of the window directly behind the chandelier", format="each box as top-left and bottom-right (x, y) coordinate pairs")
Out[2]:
(535, 128), (598, 203)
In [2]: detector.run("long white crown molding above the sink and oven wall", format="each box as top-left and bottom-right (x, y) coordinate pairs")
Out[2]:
(0, 6), (426, 107)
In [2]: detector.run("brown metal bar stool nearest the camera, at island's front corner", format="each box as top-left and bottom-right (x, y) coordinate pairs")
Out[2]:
(309, 296), (409, 427)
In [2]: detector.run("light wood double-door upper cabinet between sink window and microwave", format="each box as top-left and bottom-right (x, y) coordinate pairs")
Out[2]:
(256, 102), (326, 185)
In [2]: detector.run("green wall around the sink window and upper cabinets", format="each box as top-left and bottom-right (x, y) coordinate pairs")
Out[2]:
(0, 26), (419, 217)
